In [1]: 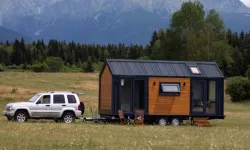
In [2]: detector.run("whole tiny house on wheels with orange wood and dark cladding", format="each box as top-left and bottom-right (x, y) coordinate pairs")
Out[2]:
(99, 59), (224, 125)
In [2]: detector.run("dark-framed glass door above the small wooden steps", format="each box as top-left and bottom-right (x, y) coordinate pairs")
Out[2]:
(191, 80), (216, 115)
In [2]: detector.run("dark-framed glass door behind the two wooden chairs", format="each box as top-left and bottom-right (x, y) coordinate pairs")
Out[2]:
(118, 78), (147, 113)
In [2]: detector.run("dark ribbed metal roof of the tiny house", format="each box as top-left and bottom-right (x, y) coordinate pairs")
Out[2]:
(107, 59), (224, 78)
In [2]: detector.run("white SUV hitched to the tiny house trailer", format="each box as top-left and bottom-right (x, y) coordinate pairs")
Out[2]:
(3, 91), (84, 123)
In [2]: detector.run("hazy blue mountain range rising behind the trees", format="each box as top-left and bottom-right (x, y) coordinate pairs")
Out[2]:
(0, 0), (250, 44)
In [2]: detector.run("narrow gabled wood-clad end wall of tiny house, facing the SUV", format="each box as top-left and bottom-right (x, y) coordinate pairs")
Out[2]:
(100, 65), (112, 110)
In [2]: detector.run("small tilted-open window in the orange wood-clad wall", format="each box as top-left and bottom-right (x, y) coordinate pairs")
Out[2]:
(160, 83), (181, 95)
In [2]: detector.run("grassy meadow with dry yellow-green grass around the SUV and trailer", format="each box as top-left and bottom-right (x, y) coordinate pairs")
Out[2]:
(0, 72), (250, 150)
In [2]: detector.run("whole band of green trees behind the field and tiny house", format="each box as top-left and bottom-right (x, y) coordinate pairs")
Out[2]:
(0, 1), (250, 77)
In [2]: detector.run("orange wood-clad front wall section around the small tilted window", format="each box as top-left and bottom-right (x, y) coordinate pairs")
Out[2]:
(148, 77), (190, 115)
